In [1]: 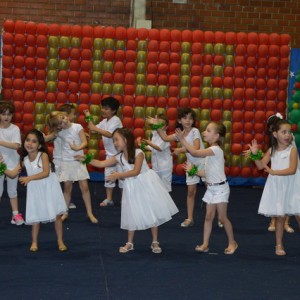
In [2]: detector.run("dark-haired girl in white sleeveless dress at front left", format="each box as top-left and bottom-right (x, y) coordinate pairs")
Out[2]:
(12, 129), (67, 252)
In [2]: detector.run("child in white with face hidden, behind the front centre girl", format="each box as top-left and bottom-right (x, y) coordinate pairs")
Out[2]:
(137, 114), (173, 192)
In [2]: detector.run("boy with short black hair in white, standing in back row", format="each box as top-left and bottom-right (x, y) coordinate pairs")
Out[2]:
(84, 97), (123, 206)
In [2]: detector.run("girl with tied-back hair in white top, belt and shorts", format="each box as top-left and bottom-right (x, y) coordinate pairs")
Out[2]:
(176, 122), (238, 254)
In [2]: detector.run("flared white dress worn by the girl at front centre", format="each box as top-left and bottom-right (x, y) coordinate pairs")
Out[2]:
(116, 149), (178, 230)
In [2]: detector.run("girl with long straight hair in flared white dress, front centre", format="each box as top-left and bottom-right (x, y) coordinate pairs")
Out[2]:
(76, 128), (178, 253)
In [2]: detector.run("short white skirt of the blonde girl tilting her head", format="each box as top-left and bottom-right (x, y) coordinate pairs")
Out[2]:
(59, 161), (90, 182)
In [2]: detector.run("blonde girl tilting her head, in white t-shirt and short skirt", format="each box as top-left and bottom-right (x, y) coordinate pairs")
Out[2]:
(47, 111), (98, 223)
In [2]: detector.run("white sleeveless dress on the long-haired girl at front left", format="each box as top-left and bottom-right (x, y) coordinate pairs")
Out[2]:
(24, 152), (67, 225)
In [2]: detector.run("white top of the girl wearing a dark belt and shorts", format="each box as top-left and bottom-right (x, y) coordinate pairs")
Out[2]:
(205, 146), (226, 183)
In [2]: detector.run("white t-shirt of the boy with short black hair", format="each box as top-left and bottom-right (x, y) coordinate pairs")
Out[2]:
(96, 116), (123, 158)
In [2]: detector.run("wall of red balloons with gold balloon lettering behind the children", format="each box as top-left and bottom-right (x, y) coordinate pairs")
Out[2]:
(2, 20), (290, 177)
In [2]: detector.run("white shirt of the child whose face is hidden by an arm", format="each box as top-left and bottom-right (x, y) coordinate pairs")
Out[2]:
(149, 130), (173, 171)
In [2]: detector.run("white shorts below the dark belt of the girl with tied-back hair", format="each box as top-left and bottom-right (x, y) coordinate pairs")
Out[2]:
(202, 182), (230, 204)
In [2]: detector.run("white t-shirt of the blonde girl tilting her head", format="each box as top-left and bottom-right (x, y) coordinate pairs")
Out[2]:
(56, 123), (83, 161)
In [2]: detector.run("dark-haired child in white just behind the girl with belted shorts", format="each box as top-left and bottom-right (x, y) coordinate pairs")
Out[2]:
(148, 108), (204, 227)
